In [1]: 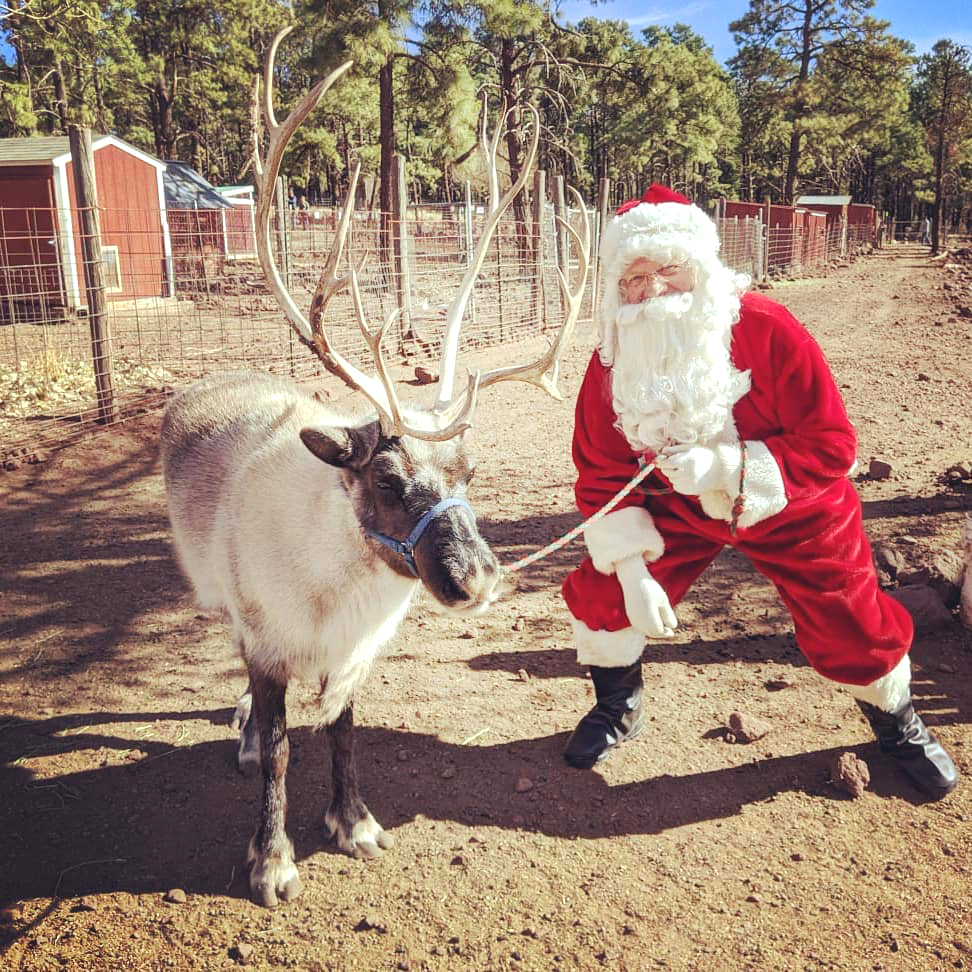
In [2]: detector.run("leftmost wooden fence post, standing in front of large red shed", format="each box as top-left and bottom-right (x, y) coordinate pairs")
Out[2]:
(68, 125), (118, 425)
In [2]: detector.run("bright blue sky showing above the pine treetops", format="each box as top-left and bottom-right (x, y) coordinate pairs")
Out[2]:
(558, 0), (972, 63)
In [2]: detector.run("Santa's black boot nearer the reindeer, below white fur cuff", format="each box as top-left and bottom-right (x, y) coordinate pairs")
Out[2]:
(564, 659), (643, 769)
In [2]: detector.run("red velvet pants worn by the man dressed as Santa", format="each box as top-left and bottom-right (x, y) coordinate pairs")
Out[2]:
(563, 479), (913, 685)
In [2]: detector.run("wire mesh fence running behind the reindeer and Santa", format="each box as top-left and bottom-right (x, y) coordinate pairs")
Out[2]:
(0, 196), (875, 468)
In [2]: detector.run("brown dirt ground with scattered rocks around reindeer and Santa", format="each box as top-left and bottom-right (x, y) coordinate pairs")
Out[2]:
(0, 237), (972, 972)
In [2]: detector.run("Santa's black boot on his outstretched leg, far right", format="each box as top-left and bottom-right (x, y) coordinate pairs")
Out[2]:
(857, 695), (958, 799)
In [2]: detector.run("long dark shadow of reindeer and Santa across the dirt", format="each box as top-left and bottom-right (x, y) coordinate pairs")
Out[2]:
(0, 692), (940, 920)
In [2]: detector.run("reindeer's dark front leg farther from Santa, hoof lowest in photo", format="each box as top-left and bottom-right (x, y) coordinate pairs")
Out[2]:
(247, 671), (301, 908)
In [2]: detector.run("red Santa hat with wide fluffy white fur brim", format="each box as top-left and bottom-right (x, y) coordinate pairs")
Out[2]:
(601, 183), (719, 289)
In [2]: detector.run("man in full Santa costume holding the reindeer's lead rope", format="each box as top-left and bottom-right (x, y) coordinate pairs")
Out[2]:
(563, 185), (957, 797)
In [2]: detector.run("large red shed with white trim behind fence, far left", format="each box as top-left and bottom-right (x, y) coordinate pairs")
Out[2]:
(0, 135), (172, 319)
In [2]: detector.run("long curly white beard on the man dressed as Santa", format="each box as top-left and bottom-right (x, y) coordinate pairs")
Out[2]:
(611, 288), (749, 452)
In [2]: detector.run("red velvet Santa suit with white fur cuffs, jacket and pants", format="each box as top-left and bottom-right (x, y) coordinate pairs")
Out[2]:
(563, 186), (912, 710)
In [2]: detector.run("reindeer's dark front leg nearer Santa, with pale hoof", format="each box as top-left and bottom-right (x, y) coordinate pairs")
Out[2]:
(324, 702), (395, 860)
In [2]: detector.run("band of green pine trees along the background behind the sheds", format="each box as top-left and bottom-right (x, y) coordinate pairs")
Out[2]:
(0, 0), (972, 211)
